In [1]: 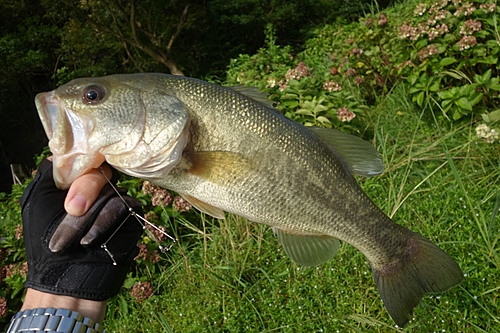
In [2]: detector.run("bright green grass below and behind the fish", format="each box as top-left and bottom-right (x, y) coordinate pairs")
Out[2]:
(105, 82), (500, 332)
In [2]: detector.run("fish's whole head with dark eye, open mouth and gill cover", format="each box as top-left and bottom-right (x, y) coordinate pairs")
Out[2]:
(35, 75), (189, 189)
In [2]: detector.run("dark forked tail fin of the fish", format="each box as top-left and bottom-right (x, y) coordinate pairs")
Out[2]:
(372, 234), (464, 327)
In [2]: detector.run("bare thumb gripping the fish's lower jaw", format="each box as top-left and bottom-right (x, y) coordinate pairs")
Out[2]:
(64, 164), (112, 216)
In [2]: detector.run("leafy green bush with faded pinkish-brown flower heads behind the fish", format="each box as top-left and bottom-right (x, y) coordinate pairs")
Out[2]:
(229, 0), (500, 126)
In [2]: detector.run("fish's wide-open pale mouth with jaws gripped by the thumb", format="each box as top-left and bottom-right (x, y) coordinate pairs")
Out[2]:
(35, 91), (105, 190)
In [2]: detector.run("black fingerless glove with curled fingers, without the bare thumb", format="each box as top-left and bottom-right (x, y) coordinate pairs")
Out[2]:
(21, 160), (143, 301)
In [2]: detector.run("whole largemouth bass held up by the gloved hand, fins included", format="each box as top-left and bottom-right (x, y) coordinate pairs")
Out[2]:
(36, 74), (463, 327)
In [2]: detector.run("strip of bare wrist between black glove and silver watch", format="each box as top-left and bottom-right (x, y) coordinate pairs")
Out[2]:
(21, 288), (107, 323)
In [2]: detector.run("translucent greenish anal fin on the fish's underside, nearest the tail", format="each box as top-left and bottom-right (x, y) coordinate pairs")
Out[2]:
(273, 228), (340, 266)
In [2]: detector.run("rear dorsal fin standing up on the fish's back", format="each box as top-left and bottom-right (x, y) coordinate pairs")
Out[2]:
(306, 127), (384, 177)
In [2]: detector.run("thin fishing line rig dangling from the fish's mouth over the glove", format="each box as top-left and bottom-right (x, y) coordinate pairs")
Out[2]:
(98, 167), (177, 266)
